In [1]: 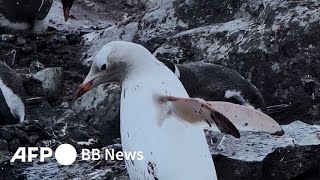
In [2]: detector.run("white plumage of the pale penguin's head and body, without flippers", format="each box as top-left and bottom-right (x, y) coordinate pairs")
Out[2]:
(76, 41), (217, 180)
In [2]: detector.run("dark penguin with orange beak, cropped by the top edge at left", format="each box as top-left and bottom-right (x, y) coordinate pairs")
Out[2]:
(0, 0), (73, 33)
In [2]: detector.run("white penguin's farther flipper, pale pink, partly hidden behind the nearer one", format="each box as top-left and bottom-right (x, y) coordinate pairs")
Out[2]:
(208, 101), (284, 136)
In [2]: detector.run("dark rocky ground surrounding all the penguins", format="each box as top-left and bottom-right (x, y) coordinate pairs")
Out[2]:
(0, 0), (320, 179)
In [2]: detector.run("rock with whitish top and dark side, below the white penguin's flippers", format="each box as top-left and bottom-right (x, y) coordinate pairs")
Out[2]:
(207, 121), (320, 180)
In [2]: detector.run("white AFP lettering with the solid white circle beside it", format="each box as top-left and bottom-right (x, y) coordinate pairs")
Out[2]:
(10, 144), (77, 165)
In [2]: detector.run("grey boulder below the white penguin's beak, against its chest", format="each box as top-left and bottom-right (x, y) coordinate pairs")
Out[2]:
(58, 84), (121, 145)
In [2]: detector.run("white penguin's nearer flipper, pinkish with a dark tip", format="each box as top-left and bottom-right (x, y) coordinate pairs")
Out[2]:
(156, 96), (240, 138)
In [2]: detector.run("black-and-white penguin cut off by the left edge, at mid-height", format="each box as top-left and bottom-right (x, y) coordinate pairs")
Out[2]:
(0, 61), (25, 126)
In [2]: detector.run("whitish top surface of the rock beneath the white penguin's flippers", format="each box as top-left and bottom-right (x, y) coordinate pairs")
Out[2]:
(210, 121), (320, 162)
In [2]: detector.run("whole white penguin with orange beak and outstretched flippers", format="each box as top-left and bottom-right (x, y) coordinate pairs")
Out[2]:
(76, 41), (283, 180)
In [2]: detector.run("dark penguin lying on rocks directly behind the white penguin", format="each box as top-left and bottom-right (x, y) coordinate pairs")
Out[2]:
(158, 58), (265, 108)
